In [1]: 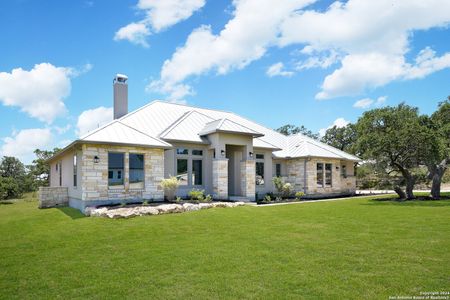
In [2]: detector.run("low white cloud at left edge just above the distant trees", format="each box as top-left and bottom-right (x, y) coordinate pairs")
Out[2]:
(0, 128), (53, 164)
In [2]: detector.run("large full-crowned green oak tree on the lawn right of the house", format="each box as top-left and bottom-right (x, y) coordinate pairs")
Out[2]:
(355, 103), (432, 199)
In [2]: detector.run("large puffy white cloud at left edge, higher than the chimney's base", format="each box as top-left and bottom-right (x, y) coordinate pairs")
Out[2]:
(0, 63), (76, 123)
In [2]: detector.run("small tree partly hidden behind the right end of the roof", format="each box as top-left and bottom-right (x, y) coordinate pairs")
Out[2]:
(321, 124), (356, 153)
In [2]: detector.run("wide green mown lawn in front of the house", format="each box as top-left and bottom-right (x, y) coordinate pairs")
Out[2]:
(0, 196), (450, 299)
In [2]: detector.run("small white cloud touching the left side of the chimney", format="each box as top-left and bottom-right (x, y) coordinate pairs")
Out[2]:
(76, 106), (113, 136)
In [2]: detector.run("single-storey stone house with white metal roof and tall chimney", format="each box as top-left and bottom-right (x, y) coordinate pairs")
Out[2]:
(41, 74), (359, 210)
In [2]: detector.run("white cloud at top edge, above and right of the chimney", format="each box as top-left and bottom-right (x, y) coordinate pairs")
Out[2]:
(114, 0), (205, 47)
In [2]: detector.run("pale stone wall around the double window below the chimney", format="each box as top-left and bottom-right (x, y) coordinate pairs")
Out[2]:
(81, 144), (164, 201)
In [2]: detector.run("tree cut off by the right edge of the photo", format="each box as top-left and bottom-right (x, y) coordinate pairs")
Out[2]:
(423, 96), (450, 199)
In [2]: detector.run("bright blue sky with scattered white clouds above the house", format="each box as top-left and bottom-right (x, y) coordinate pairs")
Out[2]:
(0, 0), (450, 163)
